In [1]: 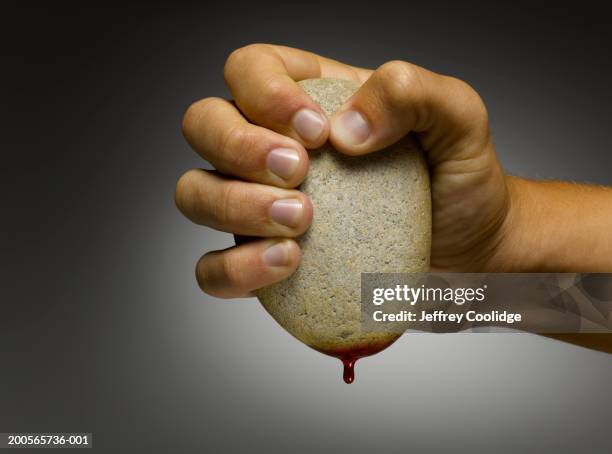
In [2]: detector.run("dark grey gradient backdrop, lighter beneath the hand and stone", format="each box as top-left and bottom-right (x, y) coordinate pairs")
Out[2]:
(0, 2), (612, 453)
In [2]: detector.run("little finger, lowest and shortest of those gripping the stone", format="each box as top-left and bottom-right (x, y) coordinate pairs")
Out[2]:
(196, 239), (300, 298)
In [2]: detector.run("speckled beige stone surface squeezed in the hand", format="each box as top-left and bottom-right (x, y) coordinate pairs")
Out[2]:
(256, 79), (431, 354)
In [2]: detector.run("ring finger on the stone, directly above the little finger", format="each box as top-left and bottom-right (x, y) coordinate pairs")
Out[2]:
(175, 170), (312, 237)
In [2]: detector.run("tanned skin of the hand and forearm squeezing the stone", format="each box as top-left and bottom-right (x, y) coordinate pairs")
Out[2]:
(176, 44), (612, 351)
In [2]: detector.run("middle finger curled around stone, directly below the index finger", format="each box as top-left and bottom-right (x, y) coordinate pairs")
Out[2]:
(183, 98), (308, 187)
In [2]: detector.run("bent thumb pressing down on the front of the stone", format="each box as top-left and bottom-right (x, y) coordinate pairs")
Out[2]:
(330, 61), (488, 163)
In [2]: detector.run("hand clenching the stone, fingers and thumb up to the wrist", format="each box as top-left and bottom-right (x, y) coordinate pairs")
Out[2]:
(176, 45), (508, 297)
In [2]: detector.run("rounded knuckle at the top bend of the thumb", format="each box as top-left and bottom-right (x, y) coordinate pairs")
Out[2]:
(379, 60), (422, 103)
